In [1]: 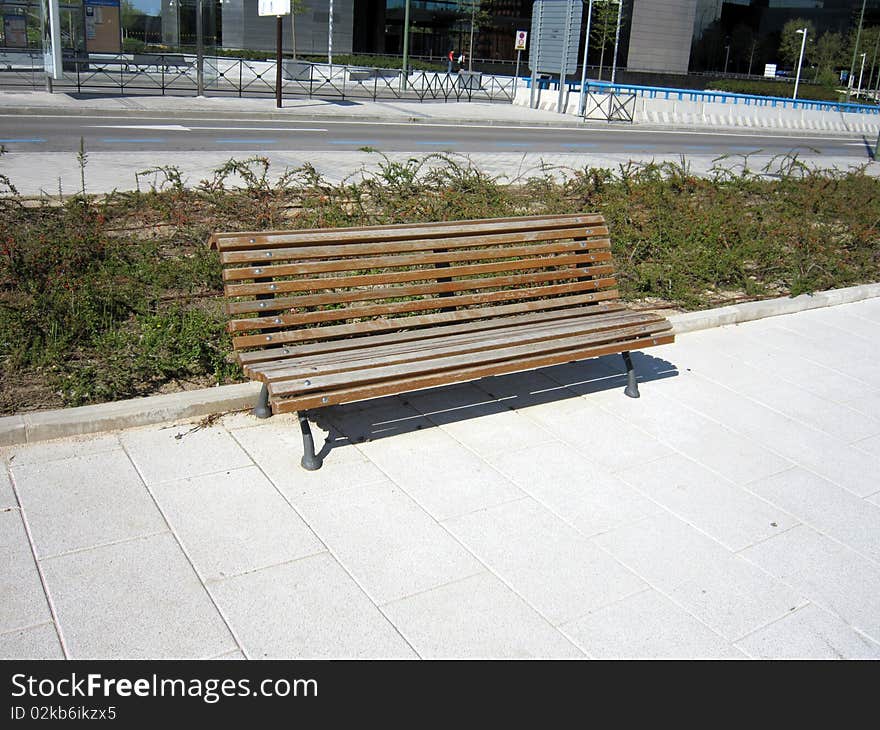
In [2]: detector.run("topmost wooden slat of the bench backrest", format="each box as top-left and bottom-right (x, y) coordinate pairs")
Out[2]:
(212, 215), (604, 251)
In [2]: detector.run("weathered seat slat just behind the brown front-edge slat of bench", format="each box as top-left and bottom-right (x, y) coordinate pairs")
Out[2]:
(268, 320), (672, 397)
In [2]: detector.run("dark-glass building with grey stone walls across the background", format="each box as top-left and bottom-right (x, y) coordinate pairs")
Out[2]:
(153, 0), (880, 74)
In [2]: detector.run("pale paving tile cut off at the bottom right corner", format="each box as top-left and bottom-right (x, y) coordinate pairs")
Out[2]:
(736, 604), (880, 659)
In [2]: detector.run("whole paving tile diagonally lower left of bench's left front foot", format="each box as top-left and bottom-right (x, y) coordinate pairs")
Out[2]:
(153, 466), (325, 580)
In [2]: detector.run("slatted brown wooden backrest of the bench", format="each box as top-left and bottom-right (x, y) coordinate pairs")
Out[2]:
(211, 214), (618, 364)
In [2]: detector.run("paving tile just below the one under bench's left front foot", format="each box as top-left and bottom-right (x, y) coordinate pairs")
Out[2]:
(300, 482), (483, 605)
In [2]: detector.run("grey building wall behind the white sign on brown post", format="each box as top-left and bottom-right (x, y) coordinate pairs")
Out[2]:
(223, 0), (354, 56)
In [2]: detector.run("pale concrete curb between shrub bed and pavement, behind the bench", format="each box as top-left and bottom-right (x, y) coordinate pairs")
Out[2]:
(0, 284), (880, 446)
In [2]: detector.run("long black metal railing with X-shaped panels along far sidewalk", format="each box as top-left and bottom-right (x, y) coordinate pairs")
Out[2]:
(0, 53), (514, 102)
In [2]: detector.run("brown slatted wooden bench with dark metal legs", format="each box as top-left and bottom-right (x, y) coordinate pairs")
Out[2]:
(211, 215), (673, 470)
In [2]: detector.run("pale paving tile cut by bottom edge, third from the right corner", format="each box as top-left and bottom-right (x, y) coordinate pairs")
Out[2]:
(383, 572), (583, 659)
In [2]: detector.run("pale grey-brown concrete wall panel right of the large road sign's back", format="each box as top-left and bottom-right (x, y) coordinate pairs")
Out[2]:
(626, 0), (697, 74)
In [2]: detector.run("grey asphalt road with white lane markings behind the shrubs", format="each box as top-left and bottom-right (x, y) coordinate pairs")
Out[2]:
(0, 113), (873, 161)
